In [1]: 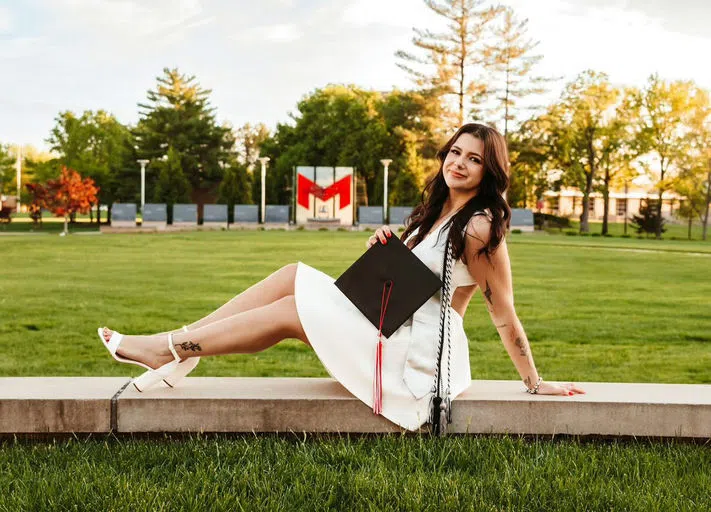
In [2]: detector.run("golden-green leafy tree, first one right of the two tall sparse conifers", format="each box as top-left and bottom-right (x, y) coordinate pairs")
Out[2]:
(551, 71), (620, 233)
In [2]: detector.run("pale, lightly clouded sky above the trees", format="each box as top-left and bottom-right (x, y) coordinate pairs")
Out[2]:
(0, 0), (711, 149)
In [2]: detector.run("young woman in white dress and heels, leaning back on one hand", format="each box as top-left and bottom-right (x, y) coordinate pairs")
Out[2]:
(99, 123), (584, 430)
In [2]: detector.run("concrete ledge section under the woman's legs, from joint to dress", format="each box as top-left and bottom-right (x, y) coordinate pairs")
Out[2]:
(117, 377), (401, 432)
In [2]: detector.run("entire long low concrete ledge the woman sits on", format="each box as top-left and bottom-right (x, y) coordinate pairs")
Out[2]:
(0, 377), (711, 438)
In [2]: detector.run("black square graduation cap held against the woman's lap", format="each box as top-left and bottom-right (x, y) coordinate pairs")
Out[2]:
(335, 235), (442, 337)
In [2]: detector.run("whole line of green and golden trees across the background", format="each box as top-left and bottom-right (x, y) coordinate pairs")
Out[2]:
(0, 0), (711, 237)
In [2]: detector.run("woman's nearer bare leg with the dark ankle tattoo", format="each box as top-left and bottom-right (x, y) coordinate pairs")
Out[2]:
(107, 295), (310, 368)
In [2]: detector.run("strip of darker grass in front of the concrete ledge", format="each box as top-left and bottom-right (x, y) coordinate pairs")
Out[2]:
(0, 435), (711, 512)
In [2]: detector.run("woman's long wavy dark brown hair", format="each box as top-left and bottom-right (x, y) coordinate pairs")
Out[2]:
(402, 123), (511, 263)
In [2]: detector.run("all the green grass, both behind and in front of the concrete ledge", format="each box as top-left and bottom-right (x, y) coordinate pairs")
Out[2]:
(0, 231), (711, 511)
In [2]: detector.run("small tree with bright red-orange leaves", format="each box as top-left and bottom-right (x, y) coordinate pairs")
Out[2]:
(43, 167), (99, 235)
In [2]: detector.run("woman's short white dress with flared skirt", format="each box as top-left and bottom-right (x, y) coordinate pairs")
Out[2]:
(294, 210), (484, 430)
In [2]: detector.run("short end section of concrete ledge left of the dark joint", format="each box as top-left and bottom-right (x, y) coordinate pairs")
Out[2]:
(0, 377), (130, 434)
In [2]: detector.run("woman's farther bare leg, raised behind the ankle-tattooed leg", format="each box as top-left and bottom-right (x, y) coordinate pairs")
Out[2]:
(158, 263), (297, 334)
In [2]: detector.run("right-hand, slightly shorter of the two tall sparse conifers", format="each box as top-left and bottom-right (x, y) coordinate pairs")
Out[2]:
(489, 7), (551, 140)
